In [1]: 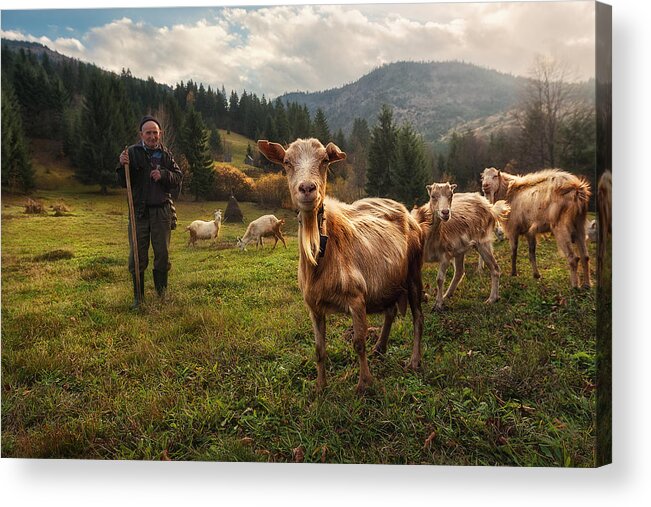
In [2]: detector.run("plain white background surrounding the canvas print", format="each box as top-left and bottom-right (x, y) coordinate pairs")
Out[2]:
(0, 0), (651, 507)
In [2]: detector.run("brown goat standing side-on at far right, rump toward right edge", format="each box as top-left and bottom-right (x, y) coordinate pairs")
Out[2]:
(481, 167), (590, 287)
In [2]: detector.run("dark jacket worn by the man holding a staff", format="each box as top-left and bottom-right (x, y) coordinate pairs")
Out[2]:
(116, 143), (183, 216)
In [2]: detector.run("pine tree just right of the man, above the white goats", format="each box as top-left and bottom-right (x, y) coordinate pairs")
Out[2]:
(183, 109), (214, 200)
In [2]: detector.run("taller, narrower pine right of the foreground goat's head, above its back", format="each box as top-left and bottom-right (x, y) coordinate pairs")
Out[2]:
(366, 104), (397, 197)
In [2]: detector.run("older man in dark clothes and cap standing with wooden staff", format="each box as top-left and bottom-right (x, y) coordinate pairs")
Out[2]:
(116, 116), (183, 309)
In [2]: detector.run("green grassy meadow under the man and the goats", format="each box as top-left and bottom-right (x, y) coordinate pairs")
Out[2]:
(2, 191), (596, 467)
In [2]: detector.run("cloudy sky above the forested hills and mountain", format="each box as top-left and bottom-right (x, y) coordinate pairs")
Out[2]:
(1, 0), (595, 98)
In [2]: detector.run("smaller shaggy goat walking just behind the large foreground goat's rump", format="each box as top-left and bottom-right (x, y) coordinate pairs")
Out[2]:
(412, 183), (509, 309)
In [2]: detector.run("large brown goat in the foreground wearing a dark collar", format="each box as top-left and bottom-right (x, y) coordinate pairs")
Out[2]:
(258, 139), (423, 393)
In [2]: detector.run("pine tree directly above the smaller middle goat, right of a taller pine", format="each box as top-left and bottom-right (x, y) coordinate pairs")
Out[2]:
(388, 123), (428, 208)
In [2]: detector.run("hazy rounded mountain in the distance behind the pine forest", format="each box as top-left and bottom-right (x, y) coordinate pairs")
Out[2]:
(281, 62), (526, 142)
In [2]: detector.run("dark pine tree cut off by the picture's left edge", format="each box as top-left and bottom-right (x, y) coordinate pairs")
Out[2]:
(0, 79), (35, 192)
